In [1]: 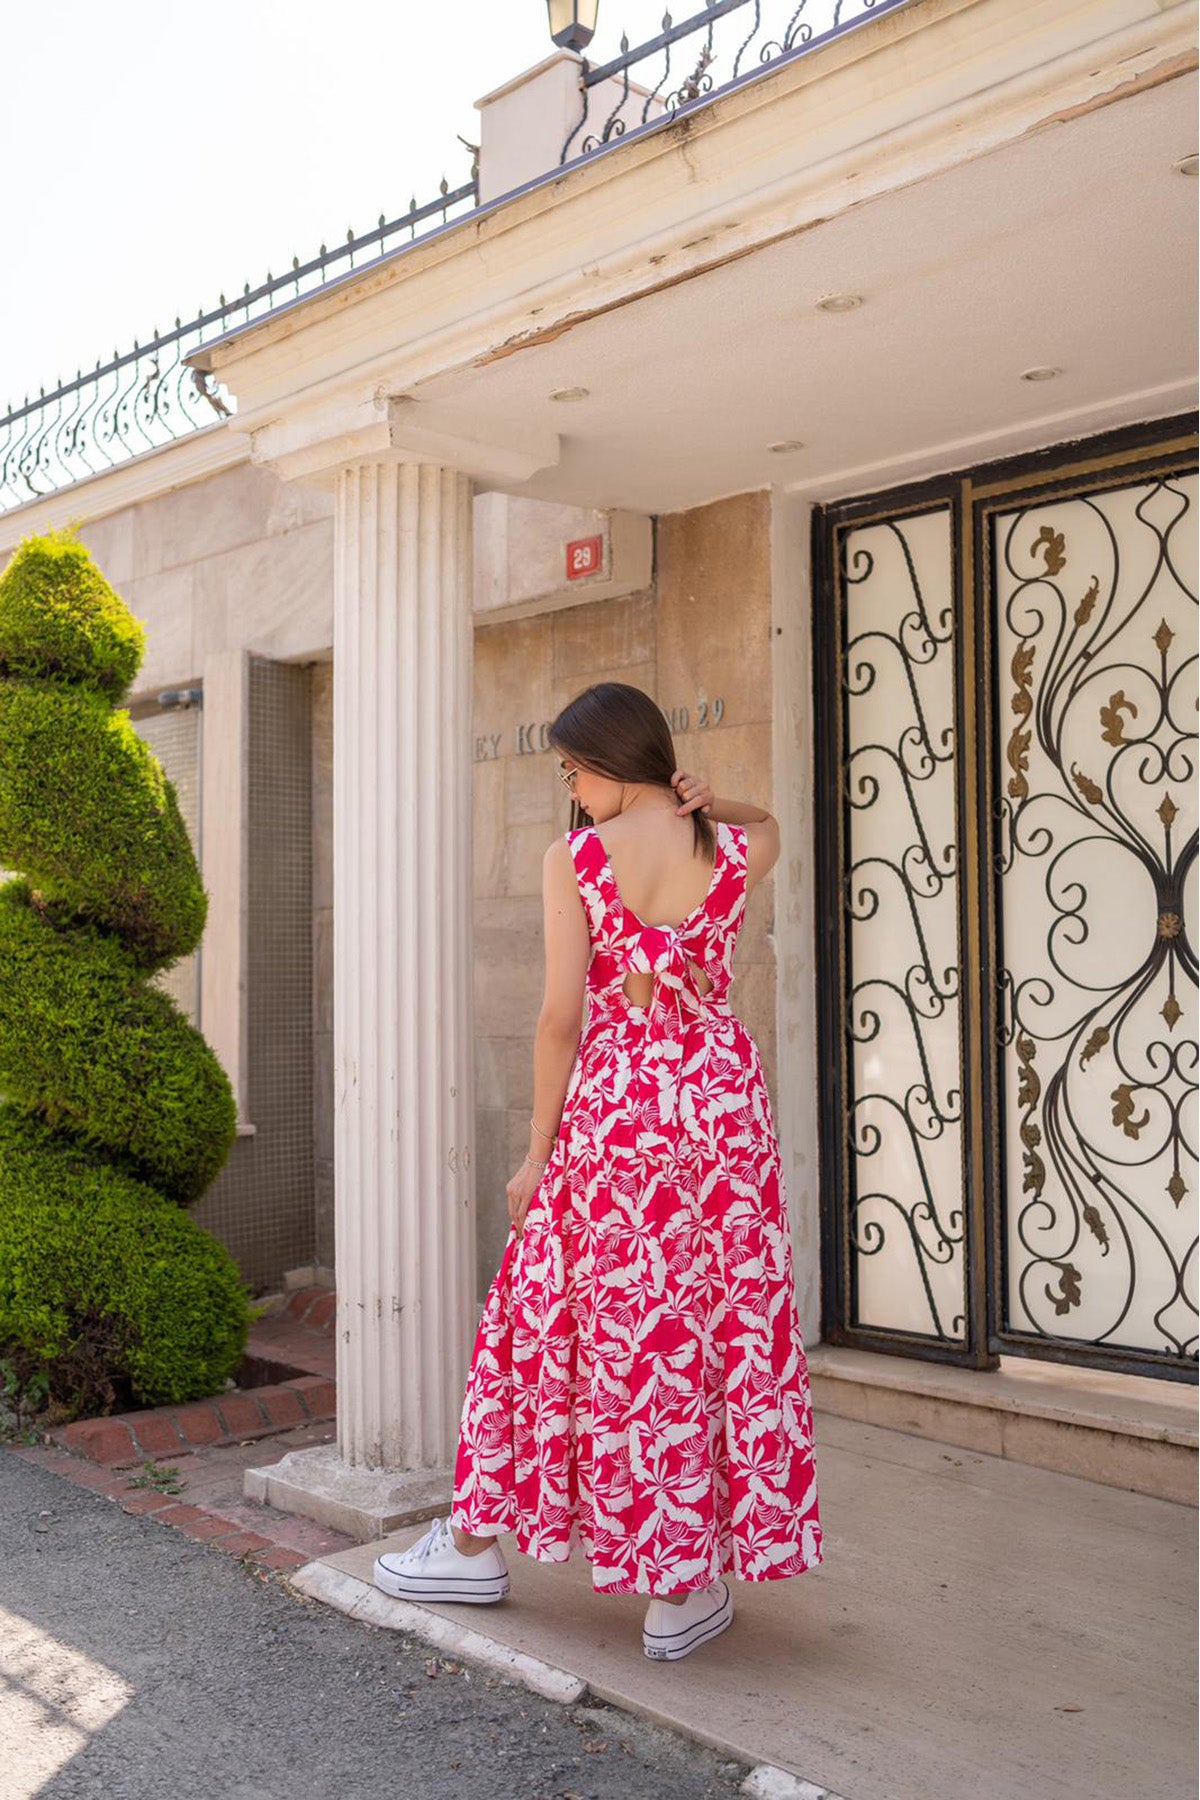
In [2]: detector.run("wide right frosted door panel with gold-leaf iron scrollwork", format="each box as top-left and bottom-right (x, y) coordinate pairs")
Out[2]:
(993, 475), (1196, 1357)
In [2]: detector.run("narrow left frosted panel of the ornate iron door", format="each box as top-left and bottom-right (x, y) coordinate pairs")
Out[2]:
(842, 508), (964, 1341)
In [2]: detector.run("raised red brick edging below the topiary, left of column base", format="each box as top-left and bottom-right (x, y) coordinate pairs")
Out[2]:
(47, 1375), (336, 1469)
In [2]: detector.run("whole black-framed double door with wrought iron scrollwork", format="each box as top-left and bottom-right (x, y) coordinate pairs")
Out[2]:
(815, 421), (1198, 1379)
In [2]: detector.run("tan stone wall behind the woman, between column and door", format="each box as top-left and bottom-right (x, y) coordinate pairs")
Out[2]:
(475, 493), (775, 1296)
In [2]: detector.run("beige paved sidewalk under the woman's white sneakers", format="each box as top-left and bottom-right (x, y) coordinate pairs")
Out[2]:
(293, 1413), (1196, 1800)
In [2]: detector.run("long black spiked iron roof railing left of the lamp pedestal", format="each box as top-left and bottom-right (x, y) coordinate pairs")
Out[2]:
(0, 172), (479, 511)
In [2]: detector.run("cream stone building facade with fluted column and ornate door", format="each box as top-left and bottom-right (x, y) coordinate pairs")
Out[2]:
(0, 0), (1196, 1521)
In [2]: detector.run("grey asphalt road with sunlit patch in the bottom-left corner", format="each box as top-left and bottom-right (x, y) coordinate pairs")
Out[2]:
(0, 1449), (747, 1800)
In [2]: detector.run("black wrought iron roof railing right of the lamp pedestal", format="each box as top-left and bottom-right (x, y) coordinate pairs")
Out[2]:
(560, 0), (907, 162)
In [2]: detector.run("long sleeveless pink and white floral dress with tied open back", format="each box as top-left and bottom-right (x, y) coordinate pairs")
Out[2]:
(450, 824), (822, 1595)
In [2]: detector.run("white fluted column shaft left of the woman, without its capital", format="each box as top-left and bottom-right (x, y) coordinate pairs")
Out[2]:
(333, 461), (473, 1472)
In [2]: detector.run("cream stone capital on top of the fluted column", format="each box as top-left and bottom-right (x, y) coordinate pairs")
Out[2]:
(241, 389), (560, 488)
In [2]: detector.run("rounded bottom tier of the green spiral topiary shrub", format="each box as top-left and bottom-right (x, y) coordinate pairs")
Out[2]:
(0, 1103), (248, 1415)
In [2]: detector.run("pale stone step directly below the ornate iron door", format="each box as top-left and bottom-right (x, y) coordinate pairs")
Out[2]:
(808, 1343), (1200, 1507)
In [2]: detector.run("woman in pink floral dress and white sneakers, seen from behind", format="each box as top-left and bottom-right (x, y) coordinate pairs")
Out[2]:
(376, 682), (822, 1660)
